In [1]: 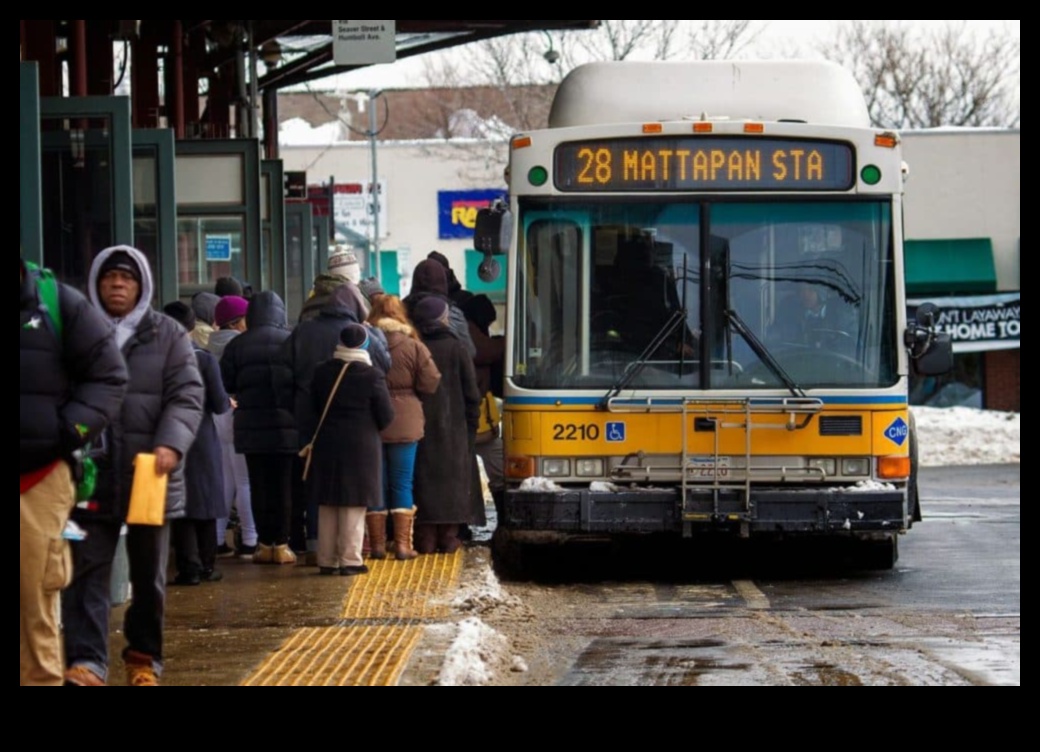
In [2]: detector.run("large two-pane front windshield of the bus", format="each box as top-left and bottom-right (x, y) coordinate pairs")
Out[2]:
(512, 197), (899, 390)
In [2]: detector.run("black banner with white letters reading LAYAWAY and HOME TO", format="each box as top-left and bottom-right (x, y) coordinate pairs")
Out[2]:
(907, 292), (1021, 353)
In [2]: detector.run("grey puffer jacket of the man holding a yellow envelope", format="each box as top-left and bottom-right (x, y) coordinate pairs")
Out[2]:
(84, 309), (205, 520)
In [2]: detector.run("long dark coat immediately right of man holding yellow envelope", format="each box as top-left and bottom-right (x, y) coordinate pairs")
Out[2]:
(184, 345), (231, 520)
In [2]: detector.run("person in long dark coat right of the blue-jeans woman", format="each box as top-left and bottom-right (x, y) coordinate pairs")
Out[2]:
(413, 295), (487, 553)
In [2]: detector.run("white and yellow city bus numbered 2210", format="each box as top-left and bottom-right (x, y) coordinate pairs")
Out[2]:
(474, 60), (953, 569)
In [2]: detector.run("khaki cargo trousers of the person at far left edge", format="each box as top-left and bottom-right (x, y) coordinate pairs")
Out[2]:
(19, 462), (76, 686)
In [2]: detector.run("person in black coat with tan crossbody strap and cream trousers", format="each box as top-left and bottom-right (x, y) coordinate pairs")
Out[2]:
(309, 323), (394, 575)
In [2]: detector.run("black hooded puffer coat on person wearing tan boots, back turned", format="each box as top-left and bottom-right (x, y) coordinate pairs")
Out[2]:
(220, 290), (300, 455)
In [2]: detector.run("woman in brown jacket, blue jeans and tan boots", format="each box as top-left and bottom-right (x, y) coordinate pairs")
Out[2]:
(366, 294), (441, 560)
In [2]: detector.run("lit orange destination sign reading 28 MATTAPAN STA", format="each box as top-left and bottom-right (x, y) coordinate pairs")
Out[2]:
(554, 136), (854, 191)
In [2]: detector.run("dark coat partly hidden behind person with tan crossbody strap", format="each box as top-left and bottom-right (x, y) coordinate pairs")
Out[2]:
(279, 285), (390, 447)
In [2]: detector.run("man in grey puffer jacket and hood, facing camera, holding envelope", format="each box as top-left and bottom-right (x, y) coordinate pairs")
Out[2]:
(61, 245), (205, 686)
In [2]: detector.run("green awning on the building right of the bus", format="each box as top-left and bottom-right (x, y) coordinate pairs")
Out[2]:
(904, 237), (996, 295)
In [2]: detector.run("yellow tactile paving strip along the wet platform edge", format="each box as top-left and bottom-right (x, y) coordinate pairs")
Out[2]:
(241, 550), (463, 686)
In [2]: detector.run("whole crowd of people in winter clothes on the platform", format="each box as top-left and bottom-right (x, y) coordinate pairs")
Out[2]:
(21, 245), (501, 685)
